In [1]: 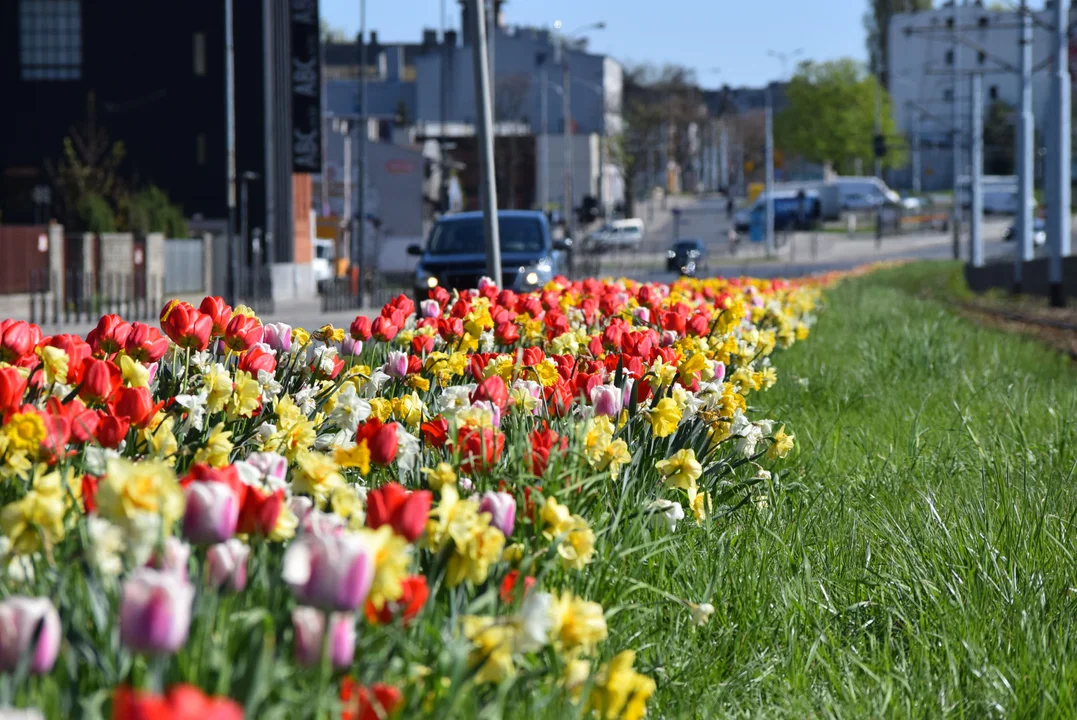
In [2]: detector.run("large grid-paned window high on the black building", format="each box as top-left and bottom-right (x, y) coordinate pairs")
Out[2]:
(18, 0), (82, 80)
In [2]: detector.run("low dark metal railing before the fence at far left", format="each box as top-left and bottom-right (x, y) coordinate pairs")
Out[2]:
(29, 270), (164, 325)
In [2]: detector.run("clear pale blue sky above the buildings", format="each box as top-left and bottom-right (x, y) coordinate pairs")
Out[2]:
(321, 0), (868, 87)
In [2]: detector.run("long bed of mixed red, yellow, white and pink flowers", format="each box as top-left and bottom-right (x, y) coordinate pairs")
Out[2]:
(0, 279), (817, 719)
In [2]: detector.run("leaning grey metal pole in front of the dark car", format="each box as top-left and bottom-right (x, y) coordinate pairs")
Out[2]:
(471, 0), (503, 286)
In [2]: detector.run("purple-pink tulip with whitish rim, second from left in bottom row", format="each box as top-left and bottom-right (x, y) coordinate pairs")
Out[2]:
(120, 567), (195, 654)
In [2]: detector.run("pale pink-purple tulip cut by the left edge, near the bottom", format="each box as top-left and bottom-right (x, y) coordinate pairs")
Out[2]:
(0, 595), (61, 675)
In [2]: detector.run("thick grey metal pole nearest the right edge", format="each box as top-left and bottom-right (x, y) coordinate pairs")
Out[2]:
(1047, 0), (1072, 308)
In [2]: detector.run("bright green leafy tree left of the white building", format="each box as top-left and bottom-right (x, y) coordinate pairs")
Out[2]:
(774, 58), (906, 173)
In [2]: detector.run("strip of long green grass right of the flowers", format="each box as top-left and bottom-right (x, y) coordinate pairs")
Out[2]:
(592, 264), (1077, 718)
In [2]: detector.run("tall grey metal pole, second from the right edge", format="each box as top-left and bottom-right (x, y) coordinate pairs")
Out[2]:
(1013, 0), (1036, 293)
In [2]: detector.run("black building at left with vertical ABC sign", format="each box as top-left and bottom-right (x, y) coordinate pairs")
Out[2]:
(0, 0), (321, 279)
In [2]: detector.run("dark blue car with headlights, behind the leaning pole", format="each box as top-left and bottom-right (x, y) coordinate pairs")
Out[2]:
(407, 210), (569, 299)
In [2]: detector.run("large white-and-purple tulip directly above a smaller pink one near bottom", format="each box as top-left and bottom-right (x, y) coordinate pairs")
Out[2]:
(281, 533), (376, 612)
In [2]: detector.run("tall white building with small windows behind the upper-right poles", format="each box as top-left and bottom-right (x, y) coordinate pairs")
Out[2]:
(886, 0), (1053, 188)
